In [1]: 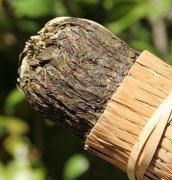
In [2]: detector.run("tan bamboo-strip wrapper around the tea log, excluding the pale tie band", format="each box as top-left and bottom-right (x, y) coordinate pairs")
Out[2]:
(85, 51), (172, 180)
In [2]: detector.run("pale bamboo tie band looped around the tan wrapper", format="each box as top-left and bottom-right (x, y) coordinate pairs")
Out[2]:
(127, 91), (172, 180)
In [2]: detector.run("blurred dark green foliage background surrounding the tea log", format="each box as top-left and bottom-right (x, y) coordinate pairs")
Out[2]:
(0, 0), (172, 180)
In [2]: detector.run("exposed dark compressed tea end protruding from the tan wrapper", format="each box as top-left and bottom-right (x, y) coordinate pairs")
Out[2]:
(18, 18), (139, 138)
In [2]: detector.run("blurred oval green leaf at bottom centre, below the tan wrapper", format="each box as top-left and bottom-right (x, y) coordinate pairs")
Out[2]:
(64, 154), (89, 180)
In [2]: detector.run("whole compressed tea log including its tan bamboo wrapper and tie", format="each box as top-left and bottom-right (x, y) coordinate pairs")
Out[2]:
(18, 17), (172, 180)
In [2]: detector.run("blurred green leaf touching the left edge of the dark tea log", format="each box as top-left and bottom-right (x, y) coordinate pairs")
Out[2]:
(5, 88), (25, 115)
